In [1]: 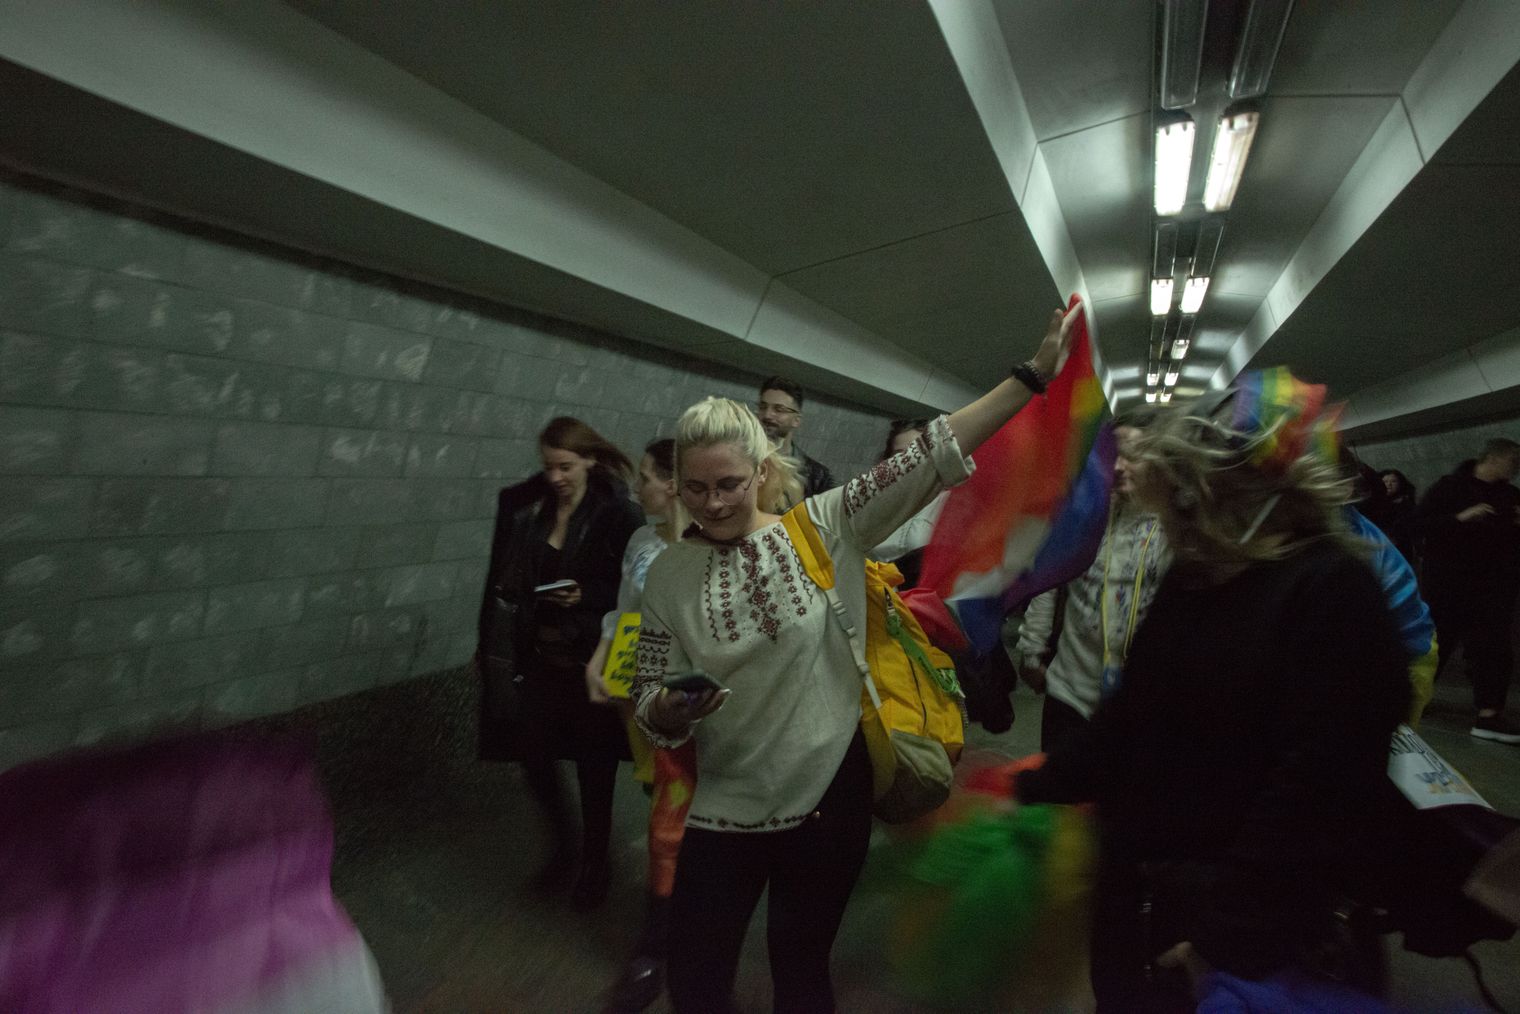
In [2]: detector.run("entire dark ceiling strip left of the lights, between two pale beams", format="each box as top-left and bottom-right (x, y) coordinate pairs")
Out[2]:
(279, 0), (1061, 388)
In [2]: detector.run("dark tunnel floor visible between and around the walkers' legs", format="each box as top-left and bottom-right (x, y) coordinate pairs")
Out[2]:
(334, 674), (1520, 1014)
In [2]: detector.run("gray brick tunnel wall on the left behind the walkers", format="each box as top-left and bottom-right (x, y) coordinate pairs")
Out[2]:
(0, 173), (886, 768)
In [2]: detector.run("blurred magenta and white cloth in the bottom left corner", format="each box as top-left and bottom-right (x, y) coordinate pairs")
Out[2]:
(0, 734), (386, 1014)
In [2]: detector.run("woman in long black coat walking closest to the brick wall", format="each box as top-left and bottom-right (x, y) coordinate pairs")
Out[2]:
(479, 417), (643, 909)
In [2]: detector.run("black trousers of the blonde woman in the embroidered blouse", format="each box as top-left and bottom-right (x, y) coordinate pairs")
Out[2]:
(666, 733), (871, 1014)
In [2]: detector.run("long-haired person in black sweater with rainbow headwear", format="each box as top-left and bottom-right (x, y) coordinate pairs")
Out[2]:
(1017, 371), (1409, 1011)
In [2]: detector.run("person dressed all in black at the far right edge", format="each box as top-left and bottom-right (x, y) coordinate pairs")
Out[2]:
(1415, 439), (1520, 743)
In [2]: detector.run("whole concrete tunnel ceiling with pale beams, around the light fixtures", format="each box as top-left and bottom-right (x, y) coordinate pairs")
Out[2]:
(0, 0), (1520, 431)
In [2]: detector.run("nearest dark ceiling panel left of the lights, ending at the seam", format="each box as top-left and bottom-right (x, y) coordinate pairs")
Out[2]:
(289, 0), (1014, 275)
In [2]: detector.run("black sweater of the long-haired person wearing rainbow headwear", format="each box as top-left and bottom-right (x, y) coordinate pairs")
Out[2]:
(1018, 541), (1409, 978)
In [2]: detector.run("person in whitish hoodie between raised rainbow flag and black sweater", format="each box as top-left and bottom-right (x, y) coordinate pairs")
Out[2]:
(1017, 409), (1172, 753)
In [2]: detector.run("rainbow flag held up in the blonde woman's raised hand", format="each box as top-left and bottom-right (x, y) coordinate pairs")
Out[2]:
(920, 295), (1113, 651)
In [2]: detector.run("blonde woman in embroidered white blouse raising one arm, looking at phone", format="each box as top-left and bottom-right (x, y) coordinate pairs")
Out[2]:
(634, 309), (1079, 1012)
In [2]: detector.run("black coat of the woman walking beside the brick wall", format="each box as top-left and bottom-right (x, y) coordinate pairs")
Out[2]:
(479, 468), (643, 760)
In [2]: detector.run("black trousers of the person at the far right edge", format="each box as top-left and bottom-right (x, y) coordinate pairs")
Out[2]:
(1426, 581), (1515, 711)
